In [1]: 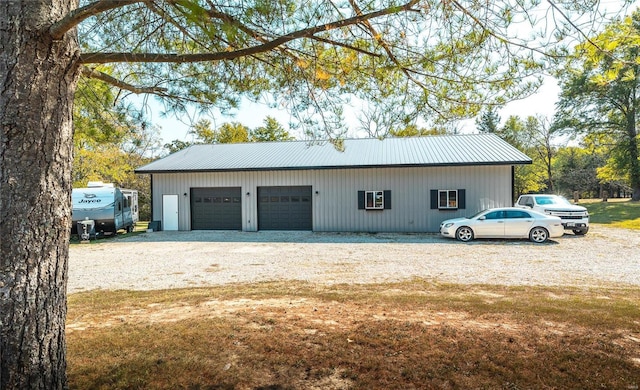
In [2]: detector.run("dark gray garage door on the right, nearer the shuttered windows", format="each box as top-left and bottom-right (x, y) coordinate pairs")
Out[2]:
(258, 186), (313, 230)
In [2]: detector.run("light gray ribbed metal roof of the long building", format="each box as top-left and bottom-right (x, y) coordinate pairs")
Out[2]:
(135, 134), (531, 173)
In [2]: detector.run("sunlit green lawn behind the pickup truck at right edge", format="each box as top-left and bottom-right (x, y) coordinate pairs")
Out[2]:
(579, 199), (640, 229)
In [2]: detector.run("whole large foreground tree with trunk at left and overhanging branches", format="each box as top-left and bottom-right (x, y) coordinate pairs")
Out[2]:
(0, 0), (632, 389)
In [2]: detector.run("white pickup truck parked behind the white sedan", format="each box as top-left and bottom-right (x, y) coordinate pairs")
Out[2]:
(515, 194), (589, 235)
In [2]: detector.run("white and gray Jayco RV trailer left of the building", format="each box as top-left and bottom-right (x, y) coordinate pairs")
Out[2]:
(71, 182), (138, 237)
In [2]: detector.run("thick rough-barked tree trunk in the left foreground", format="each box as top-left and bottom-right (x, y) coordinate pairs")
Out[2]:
(0, 0), (78, 389)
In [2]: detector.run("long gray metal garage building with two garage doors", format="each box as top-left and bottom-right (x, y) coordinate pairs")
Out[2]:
(136, 134), (531, 232)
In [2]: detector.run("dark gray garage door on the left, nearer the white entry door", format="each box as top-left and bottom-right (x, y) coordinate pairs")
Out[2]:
(191, 187), (242, 230)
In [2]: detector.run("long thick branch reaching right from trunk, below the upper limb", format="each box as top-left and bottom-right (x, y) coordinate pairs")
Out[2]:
(80, 0), (419, 64)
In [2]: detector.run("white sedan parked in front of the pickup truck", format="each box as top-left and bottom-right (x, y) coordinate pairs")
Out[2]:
(440, 207), (564, 242)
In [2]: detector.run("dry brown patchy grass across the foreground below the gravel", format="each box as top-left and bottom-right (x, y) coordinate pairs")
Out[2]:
(67, 280), (640, 390)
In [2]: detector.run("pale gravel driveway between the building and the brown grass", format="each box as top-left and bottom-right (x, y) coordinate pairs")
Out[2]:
(68, 225), (640, 293)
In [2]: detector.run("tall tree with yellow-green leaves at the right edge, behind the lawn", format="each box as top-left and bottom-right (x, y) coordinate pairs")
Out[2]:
(556, 11), (640, 201)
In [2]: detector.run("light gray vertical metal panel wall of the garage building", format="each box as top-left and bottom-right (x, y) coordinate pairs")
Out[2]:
(153, 166), (513, 232)
